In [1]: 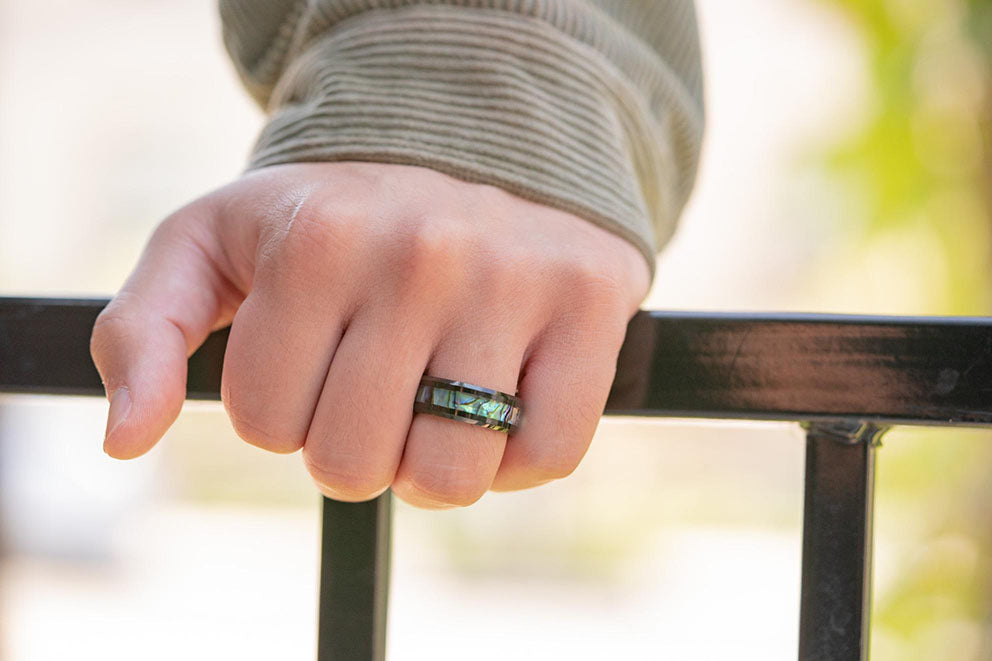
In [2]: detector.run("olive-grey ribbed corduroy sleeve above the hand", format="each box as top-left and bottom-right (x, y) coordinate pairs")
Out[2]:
(220, 0), (703, 277)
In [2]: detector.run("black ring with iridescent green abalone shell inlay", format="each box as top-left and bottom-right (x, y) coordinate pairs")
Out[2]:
(413, 374), (522, 433)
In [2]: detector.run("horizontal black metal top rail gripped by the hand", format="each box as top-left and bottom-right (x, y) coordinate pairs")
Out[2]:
(0, 298), (992, 426)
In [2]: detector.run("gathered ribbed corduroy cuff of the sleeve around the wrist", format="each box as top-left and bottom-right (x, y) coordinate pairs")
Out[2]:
(251, 5), (677, 279)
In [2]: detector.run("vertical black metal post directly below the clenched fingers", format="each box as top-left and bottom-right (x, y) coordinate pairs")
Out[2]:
(317, 491), (392, 661)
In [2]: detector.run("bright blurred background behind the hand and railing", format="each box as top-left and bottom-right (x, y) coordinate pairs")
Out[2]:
(0, 0), (992, 661)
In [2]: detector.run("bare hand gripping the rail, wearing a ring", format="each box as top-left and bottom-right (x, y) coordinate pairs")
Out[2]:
(91, 162), (649, 507)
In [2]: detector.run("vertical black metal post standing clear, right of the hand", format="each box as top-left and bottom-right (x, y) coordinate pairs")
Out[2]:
(799, 422), (885, 661)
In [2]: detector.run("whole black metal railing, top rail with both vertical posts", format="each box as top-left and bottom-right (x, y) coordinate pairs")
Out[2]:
(0, 298), (992, 661)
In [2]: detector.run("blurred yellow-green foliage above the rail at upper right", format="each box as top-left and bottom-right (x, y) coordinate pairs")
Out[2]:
(824, 0), (992, 314)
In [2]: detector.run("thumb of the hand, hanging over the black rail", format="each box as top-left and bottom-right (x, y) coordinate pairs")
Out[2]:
(90, 203), (240, 459)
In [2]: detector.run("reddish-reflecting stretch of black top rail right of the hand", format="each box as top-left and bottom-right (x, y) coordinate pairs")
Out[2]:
(607, 311), (992, 426)
